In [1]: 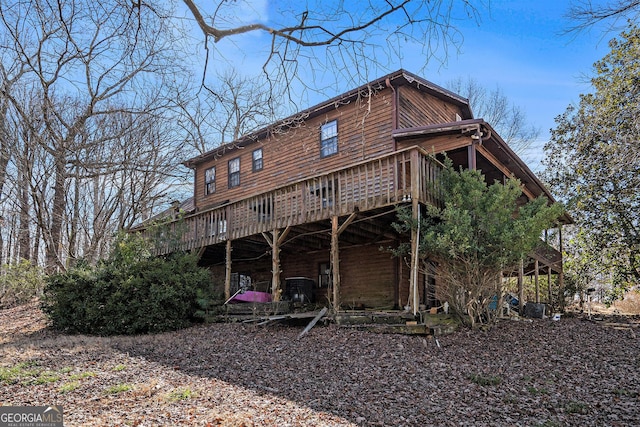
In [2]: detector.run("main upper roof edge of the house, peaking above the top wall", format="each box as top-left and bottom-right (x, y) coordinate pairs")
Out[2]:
(183, 69), (473, 168)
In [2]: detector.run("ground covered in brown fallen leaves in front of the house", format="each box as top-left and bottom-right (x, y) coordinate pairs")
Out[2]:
(0, 304), (640, 427)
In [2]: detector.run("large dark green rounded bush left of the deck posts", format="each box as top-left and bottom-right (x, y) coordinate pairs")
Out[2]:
(43, 232), (211, 335)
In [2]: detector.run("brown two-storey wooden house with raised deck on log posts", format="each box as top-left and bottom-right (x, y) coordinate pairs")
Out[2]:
(141, 70), (562, 311)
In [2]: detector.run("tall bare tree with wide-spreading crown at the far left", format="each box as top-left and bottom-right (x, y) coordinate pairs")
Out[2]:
(0, 0), (188, 271)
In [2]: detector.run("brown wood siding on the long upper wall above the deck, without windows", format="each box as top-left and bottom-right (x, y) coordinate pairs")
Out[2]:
(195, 89), (393, 209)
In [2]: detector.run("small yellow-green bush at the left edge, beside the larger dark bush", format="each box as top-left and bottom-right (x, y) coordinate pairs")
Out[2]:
(0, 260), (45, 308)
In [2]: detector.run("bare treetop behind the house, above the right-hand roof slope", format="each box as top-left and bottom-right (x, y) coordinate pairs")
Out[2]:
(447, 77), (540, 154)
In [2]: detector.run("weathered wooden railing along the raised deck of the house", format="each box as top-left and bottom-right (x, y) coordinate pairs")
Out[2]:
(145, 147), (442, 253)
